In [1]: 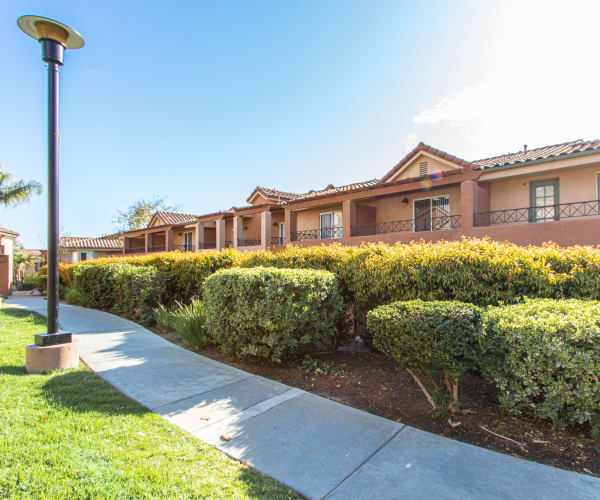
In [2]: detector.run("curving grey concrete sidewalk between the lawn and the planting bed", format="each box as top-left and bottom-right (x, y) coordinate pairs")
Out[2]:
(7, 297), (600, 500)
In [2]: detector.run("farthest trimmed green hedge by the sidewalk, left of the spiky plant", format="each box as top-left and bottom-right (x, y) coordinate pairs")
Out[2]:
(74, 263), (166, 324)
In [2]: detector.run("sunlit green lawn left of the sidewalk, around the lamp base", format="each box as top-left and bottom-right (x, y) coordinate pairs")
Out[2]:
(0, 308), (299, 498)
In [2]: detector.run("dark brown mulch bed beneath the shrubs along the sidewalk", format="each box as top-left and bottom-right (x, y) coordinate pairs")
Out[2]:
(153, 329), (600, 476)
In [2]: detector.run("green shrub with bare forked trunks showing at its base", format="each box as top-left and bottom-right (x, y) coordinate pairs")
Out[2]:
(367, 300), (484, 411)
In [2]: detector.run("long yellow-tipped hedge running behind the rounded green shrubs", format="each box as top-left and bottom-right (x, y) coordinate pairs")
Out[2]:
(50, 239), (600, 313)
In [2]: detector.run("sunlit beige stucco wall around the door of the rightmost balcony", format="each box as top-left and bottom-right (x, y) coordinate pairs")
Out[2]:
(490, 167), (600, 210)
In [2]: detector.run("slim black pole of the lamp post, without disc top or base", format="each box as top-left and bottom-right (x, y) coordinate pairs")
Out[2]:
(40, 38), (64, 333)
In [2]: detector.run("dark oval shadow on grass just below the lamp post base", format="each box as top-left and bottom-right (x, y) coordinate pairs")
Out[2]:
(42, 369), (150, 415)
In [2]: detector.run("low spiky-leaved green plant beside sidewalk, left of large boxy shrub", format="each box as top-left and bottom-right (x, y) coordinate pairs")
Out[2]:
(155, 300), (208, 347)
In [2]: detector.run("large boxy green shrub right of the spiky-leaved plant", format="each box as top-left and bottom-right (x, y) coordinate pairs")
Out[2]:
(203, 267), (344, 363)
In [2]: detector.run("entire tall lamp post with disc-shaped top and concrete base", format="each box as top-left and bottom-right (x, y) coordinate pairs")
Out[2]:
(17, 16), (84, 371)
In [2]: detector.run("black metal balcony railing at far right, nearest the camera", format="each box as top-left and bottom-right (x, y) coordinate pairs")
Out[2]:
(473, 200), (600, 227)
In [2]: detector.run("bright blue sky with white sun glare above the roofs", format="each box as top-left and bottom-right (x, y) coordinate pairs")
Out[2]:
(0, 0), (600, 248)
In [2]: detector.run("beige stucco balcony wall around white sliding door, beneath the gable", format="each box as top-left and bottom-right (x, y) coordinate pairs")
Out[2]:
(357, 186), (460, 222)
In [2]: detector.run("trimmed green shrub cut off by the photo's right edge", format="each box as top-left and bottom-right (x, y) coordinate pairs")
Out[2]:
(482, 300), (600, 429)
